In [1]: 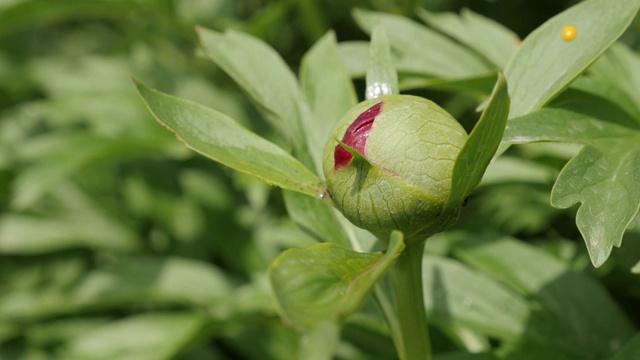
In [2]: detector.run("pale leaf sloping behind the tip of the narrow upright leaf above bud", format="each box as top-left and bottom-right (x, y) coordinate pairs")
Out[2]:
(353, 9), (491, 78)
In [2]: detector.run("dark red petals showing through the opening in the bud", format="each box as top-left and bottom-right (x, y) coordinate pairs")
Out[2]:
(334, 102), (382, 170)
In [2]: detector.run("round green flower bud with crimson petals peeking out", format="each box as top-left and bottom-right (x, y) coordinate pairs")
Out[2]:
(323, 95), (467, 241)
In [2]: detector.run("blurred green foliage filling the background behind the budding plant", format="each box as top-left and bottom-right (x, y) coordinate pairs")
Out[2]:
(0, 0), (640, 359)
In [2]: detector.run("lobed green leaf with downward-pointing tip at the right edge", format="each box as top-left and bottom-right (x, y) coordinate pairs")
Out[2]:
(551, 138), (640, 267)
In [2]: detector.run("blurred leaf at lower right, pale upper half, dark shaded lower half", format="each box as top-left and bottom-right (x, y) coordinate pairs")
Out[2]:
(454, 238), (634, 359)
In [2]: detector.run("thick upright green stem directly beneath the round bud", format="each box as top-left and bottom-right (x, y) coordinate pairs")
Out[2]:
(391, 241), (431, 360)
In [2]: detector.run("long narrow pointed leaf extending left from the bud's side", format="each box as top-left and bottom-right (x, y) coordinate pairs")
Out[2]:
(136, 78), (324, 200)
